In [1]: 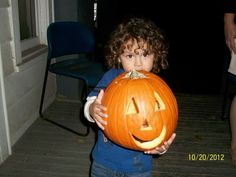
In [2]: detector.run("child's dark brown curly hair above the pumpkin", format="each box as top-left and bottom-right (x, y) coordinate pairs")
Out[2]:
(105, 18), (168, 73)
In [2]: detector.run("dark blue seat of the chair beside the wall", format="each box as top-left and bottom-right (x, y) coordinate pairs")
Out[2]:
(49, 58), (105, 87)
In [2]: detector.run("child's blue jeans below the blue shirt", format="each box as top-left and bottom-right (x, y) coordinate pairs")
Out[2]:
(91, 161), (152, 177)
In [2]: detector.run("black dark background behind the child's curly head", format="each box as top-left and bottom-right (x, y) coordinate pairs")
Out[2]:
(96, 0), (228, 94)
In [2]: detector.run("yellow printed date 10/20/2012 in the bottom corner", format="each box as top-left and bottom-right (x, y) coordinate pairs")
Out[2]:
(188, 153), (225, 161)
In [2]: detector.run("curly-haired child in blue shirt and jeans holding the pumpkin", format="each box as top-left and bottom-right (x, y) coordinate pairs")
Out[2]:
(84, 18), (175, 177)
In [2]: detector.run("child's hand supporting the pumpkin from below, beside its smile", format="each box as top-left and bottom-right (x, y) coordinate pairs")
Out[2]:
(144, 133), (176, 155)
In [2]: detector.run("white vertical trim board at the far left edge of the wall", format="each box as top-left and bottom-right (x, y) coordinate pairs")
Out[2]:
(0, 43), (12, 164)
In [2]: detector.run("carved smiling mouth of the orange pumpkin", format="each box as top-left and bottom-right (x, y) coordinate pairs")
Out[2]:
(131, 126), (166, 149)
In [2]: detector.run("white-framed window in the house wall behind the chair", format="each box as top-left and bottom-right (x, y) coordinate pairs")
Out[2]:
(11, 0), (54, 68)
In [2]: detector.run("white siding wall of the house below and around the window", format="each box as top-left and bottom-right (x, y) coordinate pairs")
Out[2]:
(0, 0), (56, 145)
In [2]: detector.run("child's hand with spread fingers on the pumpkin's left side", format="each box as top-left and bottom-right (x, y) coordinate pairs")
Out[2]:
(89, 90), (107, 130)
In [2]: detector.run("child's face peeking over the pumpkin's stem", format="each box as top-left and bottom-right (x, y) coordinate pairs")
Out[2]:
(118, 40), (154, 72)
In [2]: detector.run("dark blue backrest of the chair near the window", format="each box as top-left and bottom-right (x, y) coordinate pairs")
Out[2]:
(47, 22), (95, 59)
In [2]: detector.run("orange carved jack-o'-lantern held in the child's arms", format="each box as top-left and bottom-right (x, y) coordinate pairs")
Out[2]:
(102, 71), (178, 151)
